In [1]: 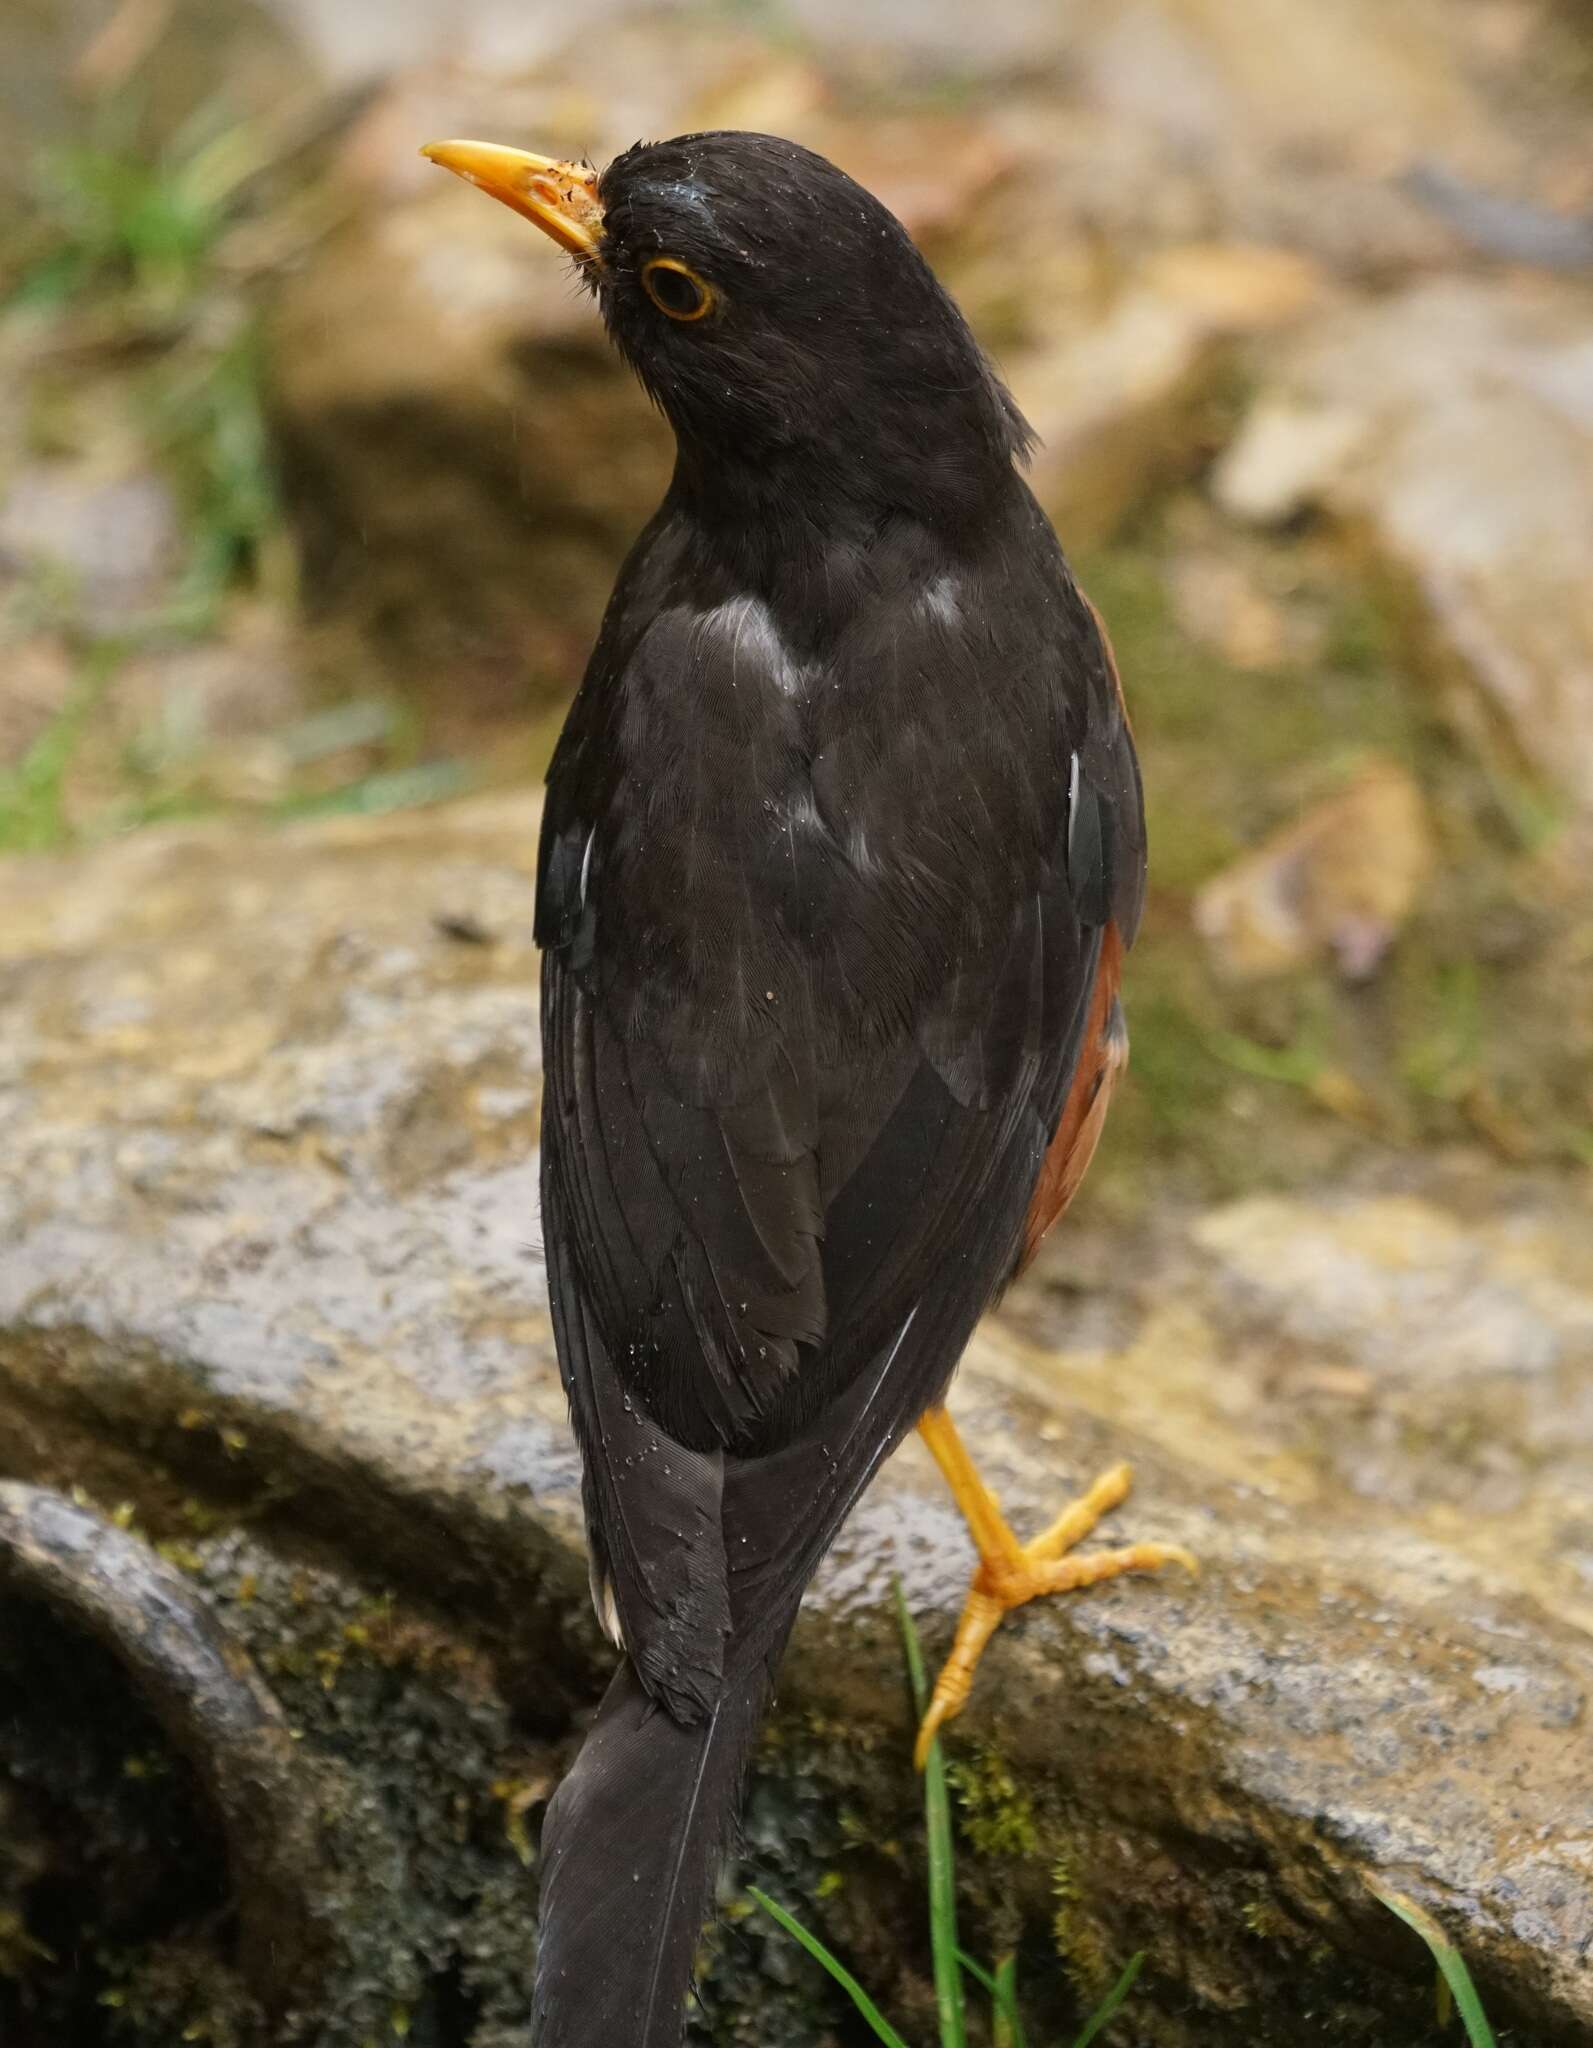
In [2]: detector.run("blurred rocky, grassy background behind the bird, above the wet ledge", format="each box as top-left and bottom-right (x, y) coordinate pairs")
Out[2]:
(0, 0), (1593, 1219)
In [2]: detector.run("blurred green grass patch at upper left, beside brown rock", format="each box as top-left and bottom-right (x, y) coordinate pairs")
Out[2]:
(0, 102), (473, 854)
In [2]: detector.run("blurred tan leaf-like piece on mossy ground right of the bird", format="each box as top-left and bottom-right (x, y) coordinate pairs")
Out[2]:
(1194, 760), (1435, 981)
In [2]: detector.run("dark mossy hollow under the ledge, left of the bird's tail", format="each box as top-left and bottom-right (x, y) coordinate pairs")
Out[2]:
(0, 1489), (557, 2048)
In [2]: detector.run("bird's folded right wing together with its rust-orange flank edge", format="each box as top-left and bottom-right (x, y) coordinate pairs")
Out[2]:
(725, 571), (1147, 1645)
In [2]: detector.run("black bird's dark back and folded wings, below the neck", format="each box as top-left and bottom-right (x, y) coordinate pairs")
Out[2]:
(539, 499), (1143, 1718)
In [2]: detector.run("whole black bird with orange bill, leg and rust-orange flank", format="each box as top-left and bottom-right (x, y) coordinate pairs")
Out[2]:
(415, 133), (1188, 2048)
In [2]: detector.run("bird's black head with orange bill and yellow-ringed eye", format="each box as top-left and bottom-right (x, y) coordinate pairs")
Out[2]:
(424, 131), (1026, 516)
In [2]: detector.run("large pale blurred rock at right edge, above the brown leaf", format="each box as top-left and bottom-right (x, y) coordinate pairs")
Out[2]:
(1214, 279), (1593, 811)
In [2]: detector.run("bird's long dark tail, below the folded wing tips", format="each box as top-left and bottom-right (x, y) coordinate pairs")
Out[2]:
(532, 1610), (794, 2048)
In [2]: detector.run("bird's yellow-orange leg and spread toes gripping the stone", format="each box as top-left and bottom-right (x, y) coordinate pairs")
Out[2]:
(913, 1409), (1198, 1769)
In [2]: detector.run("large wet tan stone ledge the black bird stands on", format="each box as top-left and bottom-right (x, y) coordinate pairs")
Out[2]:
(0, 797), (1593, 2048)
